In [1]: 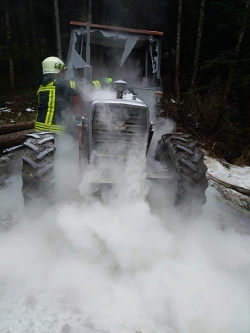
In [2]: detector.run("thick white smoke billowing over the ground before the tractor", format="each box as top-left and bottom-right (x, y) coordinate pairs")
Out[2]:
(0, 127), (250, 333)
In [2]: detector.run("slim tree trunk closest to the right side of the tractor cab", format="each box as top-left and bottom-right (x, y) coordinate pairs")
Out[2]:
(175, 0), (182, 117)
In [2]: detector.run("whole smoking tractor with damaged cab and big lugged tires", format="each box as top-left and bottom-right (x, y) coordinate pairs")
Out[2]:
(22, 22), (207, 214)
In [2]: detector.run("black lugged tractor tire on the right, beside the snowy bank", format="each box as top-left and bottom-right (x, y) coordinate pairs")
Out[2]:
(155, 133), (208, 216)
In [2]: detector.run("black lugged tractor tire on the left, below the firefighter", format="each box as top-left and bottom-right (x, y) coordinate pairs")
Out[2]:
(22, 132), (56, 208)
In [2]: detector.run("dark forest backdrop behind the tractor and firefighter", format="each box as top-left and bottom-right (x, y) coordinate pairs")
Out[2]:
(0, 0), (250, 165)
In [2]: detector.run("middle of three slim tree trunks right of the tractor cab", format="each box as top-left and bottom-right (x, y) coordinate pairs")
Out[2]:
(191, 0), (206, 89)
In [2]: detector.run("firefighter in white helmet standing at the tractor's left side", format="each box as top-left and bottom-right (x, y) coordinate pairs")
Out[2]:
(35, 57), (83, 133)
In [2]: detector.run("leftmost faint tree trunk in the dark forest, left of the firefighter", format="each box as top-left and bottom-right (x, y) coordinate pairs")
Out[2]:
(5, 0), (15, 89)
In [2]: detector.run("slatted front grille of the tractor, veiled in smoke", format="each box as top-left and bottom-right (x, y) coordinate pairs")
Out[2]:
(92, 104), (149, 160)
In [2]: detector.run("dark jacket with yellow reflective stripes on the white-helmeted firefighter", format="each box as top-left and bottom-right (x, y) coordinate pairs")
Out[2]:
(35, 74), (80, 133)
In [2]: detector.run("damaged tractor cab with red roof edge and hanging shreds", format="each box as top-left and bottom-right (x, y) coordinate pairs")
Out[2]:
(66, 22), (163, 121)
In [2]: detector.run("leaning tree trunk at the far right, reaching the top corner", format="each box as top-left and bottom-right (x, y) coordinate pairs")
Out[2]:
(223, 0), (250, 101)
